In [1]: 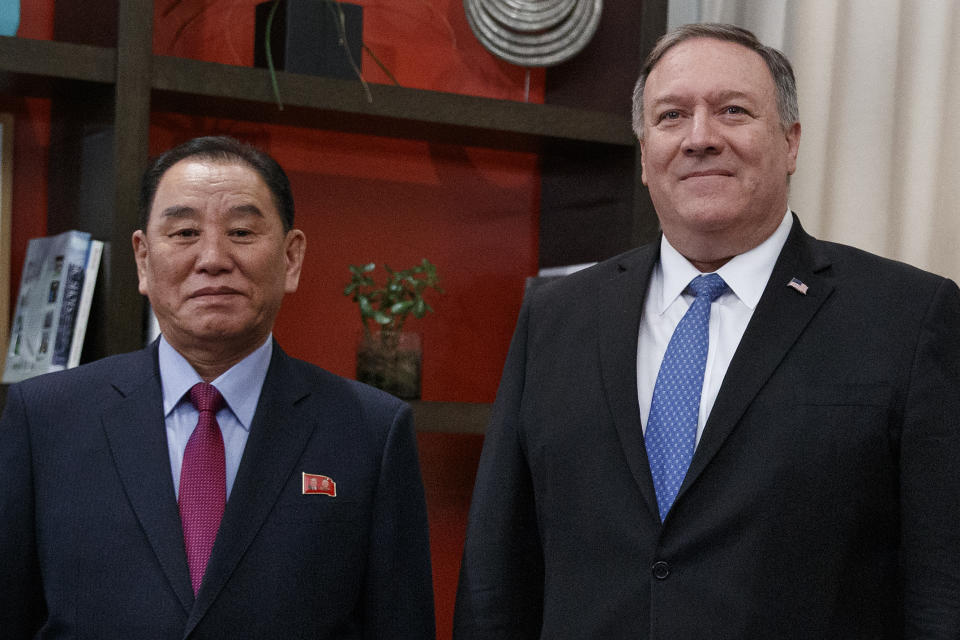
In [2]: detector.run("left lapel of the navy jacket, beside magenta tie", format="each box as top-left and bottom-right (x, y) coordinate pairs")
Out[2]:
(103, 344), (193, 611)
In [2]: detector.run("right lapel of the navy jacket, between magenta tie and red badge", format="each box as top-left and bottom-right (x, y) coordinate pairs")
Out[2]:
(184, 342), (314, 637)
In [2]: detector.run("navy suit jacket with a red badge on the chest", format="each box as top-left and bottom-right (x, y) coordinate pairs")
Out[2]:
(0, 344), (434, 640)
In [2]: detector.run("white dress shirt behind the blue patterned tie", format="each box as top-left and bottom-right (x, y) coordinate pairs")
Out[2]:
(637, 209), (793, 444)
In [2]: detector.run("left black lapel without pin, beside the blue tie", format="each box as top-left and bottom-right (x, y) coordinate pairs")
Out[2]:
(597, 242), (660, 519)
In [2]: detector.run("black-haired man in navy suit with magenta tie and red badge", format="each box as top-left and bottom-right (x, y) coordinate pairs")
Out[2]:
(0, 137), (434, 640)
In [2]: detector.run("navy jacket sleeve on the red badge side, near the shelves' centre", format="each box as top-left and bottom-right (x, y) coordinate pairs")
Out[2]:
(364, 405), (435, 640)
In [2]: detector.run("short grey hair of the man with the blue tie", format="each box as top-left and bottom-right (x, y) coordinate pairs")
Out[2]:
(633, 22), (800, 140)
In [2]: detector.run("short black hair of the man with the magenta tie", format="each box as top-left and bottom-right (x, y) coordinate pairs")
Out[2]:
(138, 136), (293, 231)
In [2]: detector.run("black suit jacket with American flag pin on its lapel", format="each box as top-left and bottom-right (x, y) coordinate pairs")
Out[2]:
(454, 220), (960, 640)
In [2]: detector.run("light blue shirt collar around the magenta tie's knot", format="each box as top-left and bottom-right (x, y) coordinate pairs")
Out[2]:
(159, 335), (273, 431)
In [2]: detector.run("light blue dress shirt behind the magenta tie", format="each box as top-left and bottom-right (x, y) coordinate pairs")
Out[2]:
(159, 335), (273, 500)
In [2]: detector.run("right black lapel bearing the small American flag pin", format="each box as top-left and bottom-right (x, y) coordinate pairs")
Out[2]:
(677, 217), (833, 500)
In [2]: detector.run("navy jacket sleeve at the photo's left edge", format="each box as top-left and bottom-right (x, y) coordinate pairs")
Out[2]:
(0, 386), (46, 639)
